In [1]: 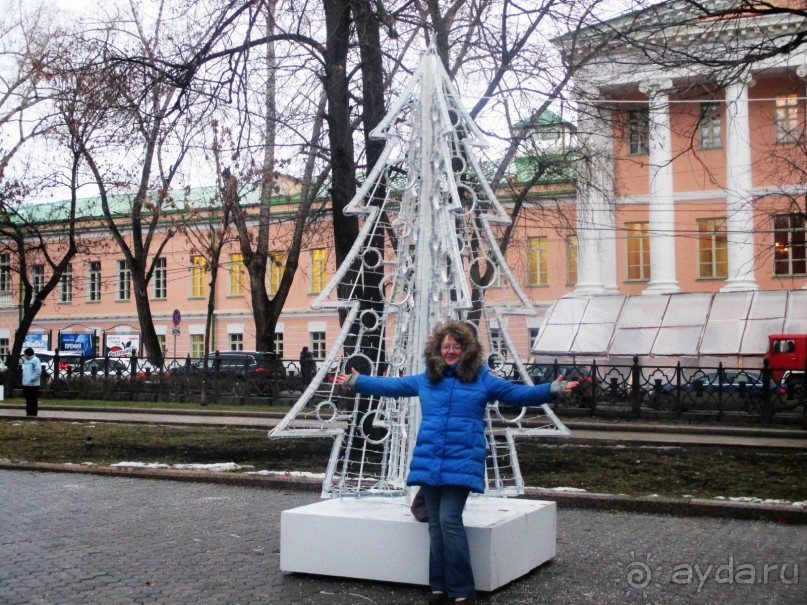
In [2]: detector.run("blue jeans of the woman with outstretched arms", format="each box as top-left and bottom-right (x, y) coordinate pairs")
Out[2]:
(420, 485), (475, 599)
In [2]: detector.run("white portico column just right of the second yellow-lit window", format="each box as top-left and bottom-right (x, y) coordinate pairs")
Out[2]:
(721, 74), (759, 292)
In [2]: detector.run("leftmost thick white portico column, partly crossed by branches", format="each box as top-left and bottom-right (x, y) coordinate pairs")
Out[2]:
(574, 91), (616, 296)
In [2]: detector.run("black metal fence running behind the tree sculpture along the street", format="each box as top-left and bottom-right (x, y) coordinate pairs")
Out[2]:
(3, 352), (807, 428)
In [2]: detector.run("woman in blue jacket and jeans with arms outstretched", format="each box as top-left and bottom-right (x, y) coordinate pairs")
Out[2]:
(336, 321), (577, 605)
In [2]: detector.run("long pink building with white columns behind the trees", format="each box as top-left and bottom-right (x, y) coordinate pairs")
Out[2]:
(0, 2), (807, 366)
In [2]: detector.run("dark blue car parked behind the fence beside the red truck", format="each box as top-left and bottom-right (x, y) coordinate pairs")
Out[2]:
(644, 371), (786, 414)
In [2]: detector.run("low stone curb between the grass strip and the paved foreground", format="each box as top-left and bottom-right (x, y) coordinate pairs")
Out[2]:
(0, 460), (807, 525)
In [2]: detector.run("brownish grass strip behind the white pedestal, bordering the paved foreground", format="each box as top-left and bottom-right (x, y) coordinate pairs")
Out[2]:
(0, 418), (807, 502)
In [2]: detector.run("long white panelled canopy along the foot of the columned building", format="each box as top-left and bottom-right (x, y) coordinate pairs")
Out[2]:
(533, 290), (807, 365)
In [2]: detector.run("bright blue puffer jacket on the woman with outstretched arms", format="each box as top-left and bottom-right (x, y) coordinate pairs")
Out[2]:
(355, 365), (551, 492)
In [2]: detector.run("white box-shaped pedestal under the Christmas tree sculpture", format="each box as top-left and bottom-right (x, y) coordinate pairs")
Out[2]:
(280, 497), (556, 591)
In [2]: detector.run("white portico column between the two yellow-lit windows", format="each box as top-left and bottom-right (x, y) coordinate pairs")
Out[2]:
(639, 80), (681, 294)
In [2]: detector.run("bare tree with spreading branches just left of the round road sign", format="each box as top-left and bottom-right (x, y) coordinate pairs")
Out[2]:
(62, 3), (211, 364)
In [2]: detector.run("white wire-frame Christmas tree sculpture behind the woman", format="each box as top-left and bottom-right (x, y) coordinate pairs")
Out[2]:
(270, 51), (568, 497)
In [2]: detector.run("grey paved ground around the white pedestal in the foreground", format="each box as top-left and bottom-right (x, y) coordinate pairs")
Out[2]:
(0, 470), (807, 605)
